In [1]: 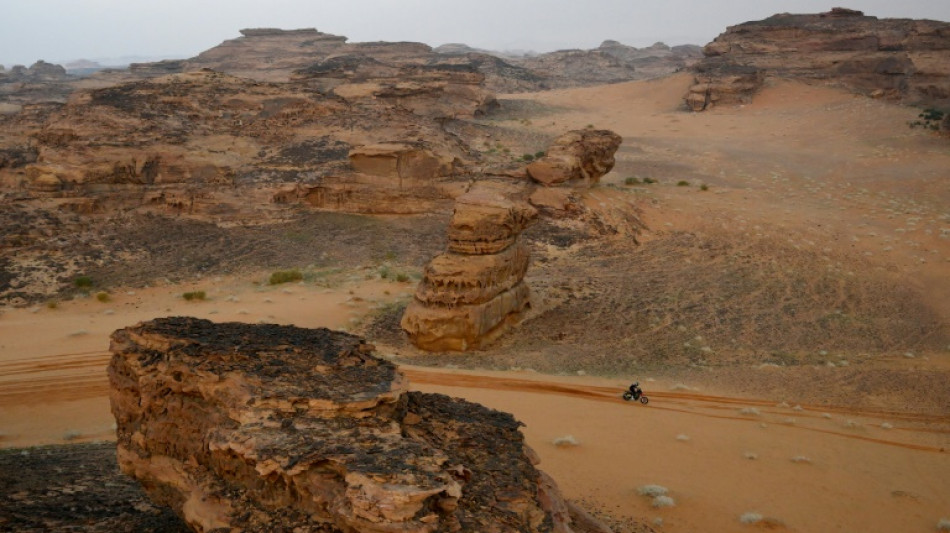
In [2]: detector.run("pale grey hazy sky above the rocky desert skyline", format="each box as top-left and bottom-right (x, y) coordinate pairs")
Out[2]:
(0, 0), (950, 68)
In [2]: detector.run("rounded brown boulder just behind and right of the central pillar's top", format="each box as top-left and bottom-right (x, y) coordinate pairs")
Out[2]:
(526, 129), (623, 187)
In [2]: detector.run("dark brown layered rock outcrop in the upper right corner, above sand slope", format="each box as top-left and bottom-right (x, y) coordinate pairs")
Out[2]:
(687, 8), (950, 111)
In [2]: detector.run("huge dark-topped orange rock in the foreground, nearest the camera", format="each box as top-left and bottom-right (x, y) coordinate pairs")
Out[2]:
(109, 317), (596, 533)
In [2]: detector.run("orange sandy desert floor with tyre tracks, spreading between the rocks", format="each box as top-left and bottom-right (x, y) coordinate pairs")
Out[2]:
(0, 72), (950, 532)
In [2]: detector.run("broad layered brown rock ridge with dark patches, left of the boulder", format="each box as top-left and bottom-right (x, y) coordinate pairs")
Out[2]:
(0, 66), (476, 218)
